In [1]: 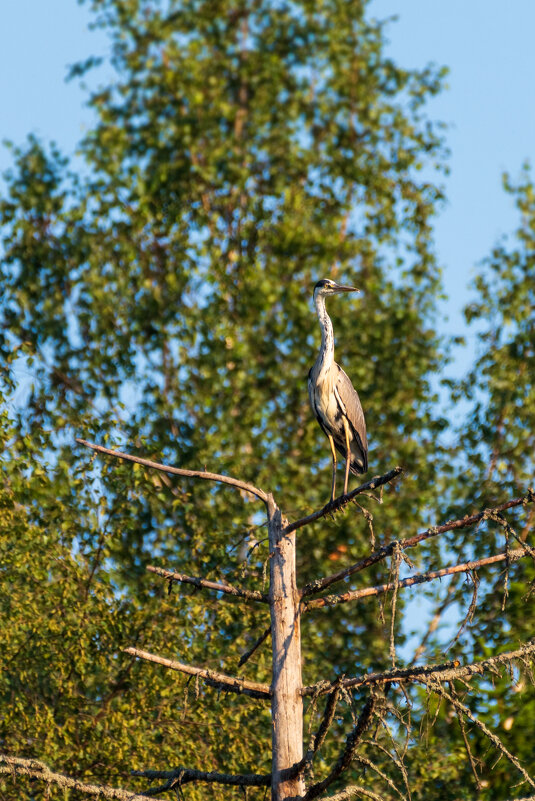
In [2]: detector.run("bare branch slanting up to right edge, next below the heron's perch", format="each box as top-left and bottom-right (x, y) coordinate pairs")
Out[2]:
(301, 488), (535, 597)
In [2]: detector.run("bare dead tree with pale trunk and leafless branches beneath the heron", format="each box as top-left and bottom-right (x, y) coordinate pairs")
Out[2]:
(0, 440), (535, 801)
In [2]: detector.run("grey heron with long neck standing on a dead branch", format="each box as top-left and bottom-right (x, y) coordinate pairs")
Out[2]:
(308, 278), (368, 503)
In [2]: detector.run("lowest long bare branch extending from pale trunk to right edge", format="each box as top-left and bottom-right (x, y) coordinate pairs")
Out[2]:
(301, 640), (535, 696)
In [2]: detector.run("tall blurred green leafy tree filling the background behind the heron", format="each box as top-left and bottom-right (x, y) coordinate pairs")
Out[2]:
(0, 0), (529, 798)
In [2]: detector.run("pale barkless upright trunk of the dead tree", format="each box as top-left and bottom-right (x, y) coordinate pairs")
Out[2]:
(267, 495), (305, 801)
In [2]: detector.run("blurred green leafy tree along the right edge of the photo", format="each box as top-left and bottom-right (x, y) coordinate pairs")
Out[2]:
(438, 166), (535, 799)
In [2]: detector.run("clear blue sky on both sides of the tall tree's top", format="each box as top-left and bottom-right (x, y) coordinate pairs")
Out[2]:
(0, 0), (535, 371)
